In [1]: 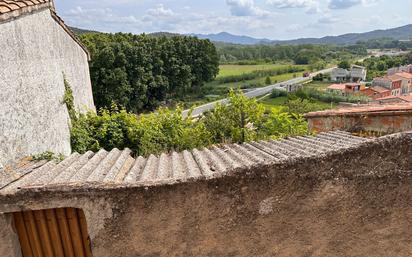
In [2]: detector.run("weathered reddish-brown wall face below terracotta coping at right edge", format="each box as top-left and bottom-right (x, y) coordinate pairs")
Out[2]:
(307, 111), (412, 134)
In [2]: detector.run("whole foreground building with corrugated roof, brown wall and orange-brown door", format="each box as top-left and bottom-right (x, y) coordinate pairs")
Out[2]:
(0, 132), (412, 257)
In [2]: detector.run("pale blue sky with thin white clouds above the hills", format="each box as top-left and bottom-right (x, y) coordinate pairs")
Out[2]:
(55, 0), (412, 40)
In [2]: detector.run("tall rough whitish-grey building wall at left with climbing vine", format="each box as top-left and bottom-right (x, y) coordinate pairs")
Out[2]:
(0, 9), (94, 165)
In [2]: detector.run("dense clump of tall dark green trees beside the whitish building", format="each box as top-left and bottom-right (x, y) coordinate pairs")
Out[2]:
(80, 33), (219, 113)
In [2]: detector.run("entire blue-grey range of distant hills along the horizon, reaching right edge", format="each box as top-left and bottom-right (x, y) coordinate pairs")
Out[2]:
(191, 25), (412, 45)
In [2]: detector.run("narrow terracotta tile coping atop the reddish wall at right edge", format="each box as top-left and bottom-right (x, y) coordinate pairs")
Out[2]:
(305, 103), (412, 118)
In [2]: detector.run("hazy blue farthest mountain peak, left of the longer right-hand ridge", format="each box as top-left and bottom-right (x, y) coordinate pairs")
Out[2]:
(189, 32), (272, 45)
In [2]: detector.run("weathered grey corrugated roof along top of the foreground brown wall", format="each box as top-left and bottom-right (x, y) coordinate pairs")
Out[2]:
(0, 132), (369, 195)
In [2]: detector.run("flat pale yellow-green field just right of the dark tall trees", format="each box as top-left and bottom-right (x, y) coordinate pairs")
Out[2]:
(217, 64), (298, 78)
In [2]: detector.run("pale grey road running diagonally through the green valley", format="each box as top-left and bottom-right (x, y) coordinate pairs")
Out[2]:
(183, 67), (335, 117)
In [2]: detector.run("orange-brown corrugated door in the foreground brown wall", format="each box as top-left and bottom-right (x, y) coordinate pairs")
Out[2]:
(13, 208), (92, 257)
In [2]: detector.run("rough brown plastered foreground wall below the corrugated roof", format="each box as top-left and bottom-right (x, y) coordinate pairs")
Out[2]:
(0, 134), (412, 257)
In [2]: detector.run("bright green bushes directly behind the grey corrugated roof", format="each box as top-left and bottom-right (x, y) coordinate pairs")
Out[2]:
(71, 91), (308, 155)
